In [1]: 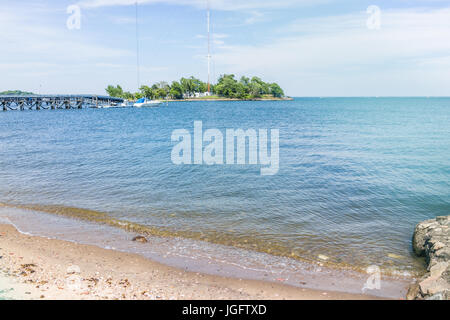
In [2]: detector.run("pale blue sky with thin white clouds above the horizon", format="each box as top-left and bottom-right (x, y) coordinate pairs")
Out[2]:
(0, 0), (450, 97)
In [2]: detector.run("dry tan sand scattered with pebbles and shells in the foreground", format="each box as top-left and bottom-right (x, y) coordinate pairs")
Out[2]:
(0, 225), (379, 300)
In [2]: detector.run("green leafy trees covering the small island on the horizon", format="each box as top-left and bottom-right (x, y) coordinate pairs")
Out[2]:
(106, 74), (284, 100)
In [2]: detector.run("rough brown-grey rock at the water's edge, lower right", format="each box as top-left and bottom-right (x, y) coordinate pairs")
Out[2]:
(407, 216), (450, 300)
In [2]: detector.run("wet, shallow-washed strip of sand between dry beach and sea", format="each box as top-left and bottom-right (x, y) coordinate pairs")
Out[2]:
(0, 206), (415, 299)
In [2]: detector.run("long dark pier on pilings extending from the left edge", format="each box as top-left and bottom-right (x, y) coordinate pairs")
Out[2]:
(0, 95), (124, 111)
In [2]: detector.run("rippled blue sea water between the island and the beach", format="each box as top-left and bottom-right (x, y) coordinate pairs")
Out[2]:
(0, 98), (450, 275)
